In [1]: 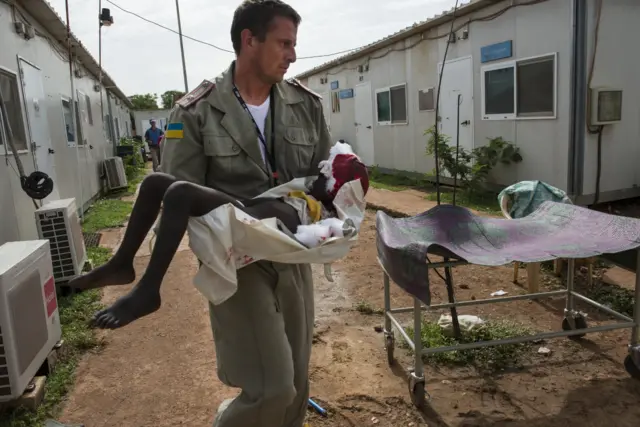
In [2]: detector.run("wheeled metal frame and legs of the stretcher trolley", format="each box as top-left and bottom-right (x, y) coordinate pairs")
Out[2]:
(378, 249), (640, 407)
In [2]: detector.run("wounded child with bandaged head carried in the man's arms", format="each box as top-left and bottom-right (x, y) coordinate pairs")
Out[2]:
(69, 142), (369, 329)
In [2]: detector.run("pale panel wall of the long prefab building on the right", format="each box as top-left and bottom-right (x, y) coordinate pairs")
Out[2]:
(304, 0), (640, 201)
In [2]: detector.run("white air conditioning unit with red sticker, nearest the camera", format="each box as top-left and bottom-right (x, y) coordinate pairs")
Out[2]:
(0, 240), (62, 402)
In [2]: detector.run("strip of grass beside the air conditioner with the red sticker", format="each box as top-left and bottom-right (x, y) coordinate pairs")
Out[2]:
(0, 290), (103, 427)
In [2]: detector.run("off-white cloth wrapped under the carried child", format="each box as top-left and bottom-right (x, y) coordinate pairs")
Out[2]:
(188, 177), (366, 304)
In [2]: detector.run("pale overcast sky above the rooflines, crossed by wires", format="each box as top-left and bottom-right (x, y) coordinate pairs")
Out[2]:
(49, 0), (466, 95)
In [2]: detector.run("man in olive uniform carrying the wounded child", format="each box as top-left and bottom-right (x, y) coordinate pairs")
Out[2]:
(161, 0), (332, 427)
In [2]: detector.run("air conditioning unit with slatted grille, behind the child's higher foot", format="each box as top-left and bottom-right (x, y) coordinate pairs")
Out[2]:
(35, 198), (87, 282)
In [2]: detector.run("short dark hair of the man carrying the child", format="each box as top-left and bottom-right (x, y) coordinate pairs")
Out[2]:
(231, 0), (302, 55)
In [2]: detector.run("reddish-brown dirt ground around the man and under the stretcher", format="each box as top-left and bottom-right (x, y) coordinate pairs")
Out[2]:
(61, 191), (640, 427)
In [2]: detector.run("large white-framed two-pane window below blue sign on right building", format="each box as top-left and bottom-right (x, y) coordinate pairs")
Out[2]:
(480, 52), (558, 121)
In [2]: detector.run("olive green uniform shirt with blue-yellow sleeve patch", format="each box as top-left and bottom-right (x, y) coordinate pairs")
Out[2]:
(161, 63), (333, 199)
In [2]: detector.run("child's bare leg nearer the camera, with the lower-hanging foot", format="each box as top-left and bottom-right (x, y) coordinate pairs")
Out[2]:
(94, 181), (239, 329)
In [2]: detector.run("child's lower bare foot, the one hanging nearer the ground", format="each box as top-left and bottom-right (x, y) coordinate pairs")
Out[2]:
(92, 283), (161, 329)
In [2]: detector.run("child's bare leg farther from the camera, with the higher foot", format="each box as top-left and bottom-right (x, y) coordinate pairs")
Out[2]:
(69, 173), (176, 289)
